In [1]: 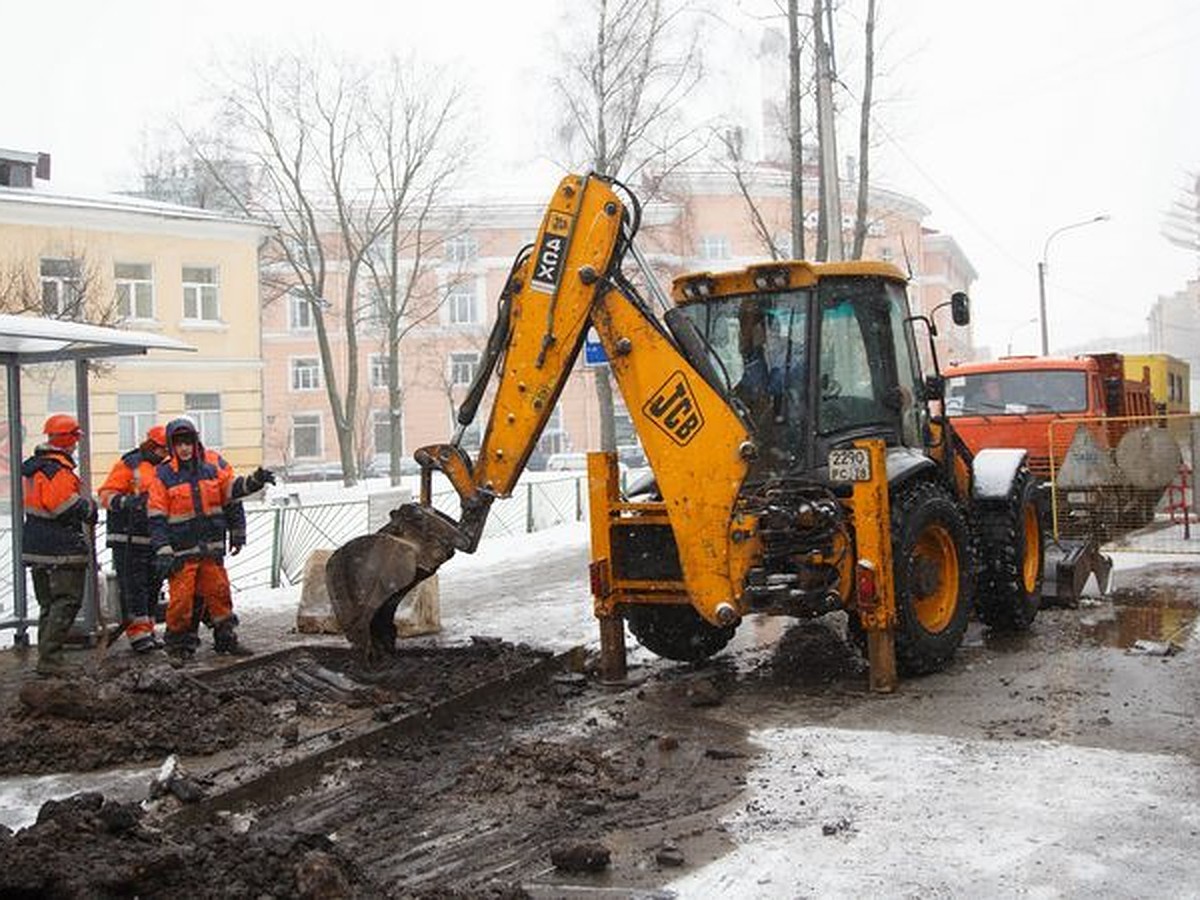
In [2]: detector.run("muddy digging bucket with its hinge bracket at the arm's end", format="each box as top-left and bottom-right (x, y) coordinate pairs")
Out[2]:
(325, 504), (454, 660)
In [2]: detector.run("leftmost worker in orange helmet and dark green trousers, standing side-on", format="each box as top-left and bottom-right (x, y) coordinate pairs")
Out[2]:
(20, 413), (96, 676)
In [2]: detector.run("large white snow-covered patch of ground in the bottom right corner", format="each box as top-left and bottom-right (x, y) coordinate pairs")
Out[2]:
(668, 727), (1200, 898)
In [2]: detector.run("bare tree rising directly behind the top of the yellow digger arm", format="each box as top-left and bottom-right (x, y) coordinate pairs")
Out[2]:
(553, 0), (703, 451)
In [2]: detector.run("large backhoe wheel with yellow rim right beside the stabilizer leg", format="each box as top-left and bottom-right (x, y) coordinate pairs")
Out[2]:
(892, 481), (974, 674)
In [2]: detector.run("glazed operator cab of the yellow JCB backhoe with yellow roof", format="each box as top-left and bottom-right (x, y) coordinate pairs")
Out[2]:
(667, 262), (929, 480)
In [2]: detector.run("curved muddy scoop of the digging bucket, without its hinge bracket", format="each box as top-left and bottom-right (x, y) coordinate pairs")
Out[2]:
(325, 534), (432, 658)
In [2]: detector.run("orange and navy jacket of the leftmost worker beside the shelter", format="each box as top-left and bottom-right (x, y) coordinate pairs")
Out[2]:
(20, 444), (92, 565)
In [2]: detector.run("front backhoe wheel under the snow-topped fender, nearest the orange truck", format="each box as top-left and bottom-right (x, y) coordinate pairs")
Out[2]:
(976, 467), (1044, 631)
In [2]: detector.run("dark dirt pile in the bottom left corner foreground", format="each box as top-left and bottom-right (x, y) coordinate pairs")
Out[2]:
(0, 793), (380, 900)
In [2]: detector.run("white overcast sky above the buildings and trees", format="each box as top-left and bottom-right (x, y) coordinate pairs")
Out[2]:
(0, 0), (1200, 353)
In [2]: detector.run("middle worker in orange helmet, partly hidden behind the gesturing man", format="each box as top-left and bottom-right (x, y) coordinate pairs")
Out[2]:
(100, 425), (167, 653)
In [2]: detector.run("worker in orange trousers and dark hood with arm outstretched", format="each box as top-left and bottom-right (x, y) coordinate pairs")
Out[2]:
(149, 418), (275, 665)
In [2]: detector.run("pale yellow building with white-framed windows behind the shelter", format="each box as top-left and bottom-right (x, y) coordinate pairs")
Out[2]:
(0, 150), (268, 473)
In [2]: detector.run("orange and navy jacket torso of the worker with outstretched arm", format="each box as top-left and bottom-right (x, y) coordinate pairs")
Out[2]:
(148, 445), (246, 558)
